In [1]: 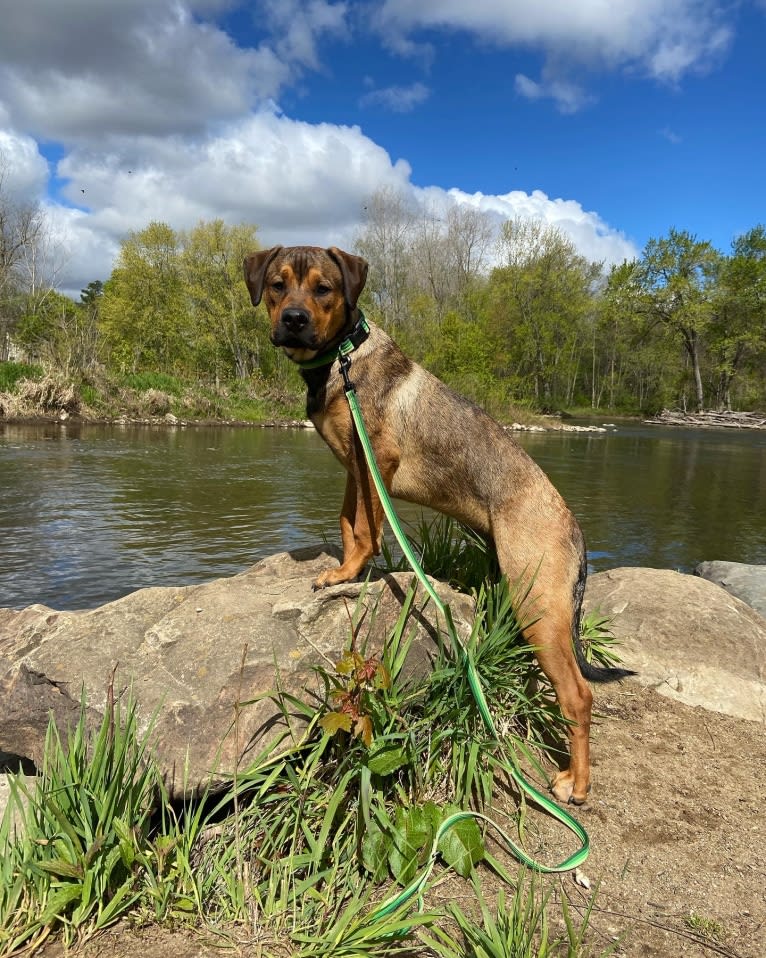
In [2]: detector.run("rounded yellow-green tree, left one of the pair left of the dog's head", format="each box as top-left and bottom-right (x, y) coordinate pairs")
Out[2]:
(99, 222), (188, 373)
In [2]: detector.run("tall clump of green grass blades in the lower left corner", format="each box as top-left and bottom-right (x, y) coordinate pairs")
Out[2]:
(0, 697), (160, 952)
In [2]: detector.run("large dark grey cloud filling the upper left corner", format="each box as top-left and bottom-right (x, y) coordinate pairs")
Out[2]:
(0, 0), (345, 143)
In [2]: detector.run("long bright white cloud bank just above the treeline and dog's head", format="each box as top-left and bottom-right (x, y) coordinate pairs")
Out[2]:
(36, 112), (637, 293)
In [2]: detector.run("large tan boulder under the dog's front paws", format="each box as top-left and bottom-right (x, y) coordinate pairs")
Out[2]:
(0, 548), (472, 797)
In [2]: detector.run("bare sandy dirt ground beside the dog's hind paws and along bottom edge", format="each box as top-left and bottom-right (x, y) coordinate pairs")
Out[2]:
(37, 682), (766, 958)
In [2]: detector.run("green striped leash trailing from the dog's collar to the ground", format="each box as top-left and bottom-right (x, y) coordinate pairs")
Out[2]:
(337, 343), (590, 904)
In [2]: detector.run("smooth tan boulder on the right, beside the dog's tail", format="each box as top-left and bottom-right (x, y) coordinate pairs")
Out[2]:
(585, 569), (766, 722)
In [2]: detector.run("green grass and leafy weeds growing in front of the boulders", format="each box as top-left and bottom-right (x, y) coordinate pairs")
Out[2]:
(0, 526), (628, 958)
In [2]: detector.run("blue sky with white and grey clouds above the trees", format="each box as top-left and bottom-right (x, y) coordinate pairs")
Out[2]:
(0, 0), (766, 297)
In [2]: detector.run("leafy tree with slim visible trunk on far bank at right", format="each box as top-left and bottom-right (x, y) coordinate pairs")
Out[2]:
(637, 229), (720, 411)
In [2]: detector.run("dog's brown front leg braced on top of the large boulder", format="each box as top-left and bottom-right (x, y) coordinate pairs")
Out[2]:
(314, 459), (398, 589)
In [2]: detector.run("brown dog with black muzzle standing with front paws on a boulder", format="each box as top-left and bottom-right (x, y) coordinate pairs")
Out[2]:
(244, 246), (627, 804)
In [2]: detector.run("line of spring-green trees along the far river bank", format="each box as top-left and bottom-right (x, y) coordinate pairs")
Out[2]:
(0, 178), (766, 416)
